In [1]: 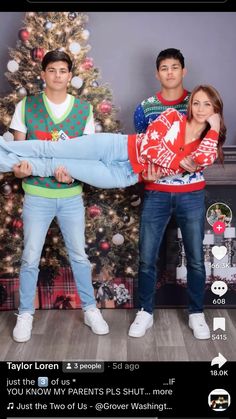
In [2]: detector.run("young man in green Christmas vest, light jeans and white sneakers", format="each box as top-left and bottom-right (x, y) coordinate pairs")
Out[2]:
(10, 50), (109, 342)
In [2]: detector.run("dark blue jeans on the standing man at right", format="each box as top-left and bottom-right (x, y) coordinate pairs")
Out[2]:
(138, 190), (206, 313)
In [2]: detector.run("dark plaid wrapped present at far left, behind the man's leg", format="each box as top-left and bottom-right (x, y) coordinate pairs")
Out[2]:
(0, 278), (39, 311)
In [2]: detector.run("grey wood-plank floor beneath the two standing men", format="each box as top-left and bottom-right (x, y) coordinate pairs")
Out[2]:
(0, 308), (236, 361)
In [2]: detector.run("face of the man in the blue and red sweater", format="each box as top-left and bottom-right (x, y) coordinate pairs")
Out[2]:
(156, 58), (186, 89)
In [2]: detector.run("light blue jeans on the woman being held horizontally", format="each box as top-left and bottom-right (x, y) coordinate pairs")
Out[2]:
(0, 133), (138, 188)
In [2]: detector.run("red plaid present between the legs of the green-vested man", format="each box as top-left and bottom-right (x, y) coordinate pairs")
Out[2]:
(38, 268), (81, 310)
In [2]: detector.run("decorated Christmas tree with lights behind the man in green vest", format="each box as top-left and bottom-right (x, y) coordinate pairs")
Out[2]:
(0, 12), (140, 306)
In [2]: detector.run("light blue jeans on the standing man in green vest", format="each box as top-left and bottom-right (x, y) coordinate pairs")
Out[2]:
(19, 194), (96, 314)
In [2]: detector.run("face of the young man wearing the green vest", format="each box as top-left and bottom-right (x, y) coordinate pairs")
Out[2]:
(41, 61), (72, 92)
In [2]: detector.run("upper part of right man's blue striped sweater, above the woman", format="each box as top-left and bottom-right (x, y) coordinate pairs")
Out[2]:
(134, 90), (190, 134)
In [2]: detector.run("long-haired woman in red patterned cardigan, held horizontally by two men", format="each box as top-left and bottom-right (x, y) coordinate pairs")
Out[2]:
(0, 86), (226, 188)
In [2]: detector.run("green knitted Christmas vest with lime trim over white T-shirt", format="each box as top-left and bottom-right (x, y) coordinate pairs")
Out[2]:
(22, 93), (92, 198)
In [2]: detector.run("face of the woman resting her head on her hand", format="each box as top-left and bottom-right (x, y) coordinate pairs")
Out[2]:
(192, 90), (214, 124)
